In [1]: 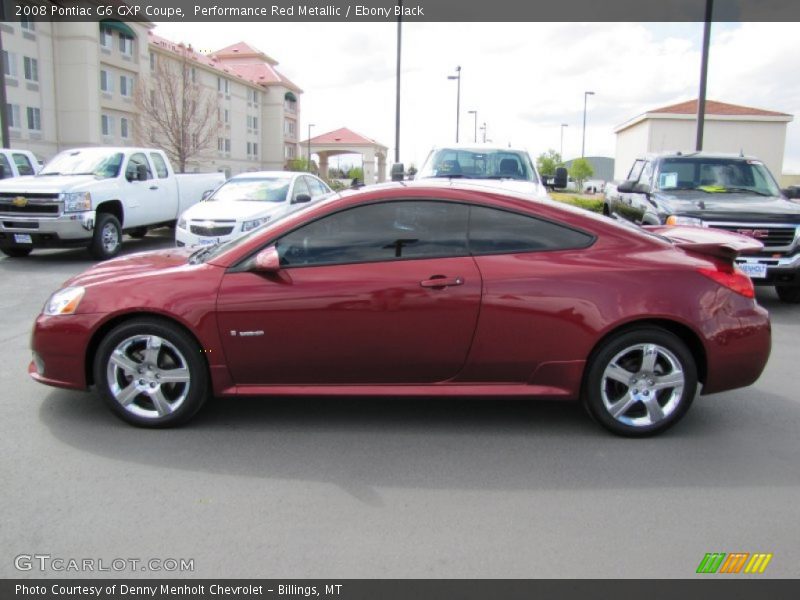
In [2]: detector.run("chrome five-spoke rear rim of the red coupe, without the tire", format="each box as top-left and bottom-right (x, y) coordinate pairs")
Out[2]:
(600, 344), (686, 427)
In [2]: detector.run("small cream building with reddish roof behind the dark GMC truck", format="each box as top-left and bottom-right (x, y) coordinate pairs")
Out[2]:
(614, 100), (792, 179)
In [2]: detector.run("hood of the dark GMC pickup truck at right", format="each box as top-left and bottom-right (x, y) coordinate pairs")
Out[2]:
(655, 190), (800, 223)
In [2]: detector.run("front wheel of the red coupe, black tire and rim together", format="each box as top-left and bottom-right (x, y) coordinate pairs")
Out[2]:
(93, 318), (209, 428)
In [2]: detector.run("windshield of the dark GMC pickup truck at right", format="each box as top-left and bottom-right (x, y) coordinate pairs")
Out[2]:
(656, 157), (780, 196)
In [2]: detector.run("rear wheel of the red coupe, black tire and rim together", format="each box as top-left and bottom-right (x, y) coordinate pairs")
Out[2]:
(583, 327), (698, 437)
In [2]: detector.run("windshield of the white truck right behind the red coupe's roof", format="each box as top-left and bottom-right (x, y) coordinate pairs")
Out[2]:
(418, 148), (536, 181)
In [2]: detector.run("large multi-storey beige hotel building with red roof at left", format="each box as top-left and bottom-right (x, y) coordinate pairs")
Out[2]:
(0, 20), (302, 174)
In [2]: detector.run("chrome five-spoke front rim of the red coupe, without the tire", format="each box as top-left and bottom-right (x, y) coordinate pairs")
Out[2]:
(106, 335), (191, 419)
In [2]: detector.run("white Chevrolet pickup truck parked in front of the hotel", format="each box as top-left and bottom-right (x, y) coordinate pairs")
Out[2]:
(0, 147), (225, 260)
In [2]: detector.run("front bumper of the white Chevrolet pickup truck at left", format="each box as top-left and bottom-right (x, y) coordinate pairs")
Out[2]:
(0, 211), (95, 248)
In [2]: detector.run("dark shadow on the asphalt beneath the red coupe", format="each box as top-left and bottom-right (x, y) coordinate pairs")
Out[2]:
(40, 388), (800, 506)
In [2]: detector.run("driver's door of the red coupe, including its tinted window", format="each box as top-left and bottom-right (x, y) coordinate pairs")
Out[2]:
(217, 200), (481, 385)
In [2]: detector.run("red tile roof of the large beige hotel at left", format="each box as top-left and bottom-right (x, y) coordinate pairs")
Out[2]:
(148, 31), (303, 93)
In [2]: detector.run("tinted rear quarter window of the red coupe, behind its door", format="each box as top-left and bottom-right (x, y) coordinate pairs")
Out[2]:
(469, 206), (593, 254)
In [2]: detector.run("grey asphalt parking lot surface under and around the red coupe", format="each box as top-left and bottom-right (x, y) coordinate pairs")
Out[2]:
(0, 231), (800, 578)
